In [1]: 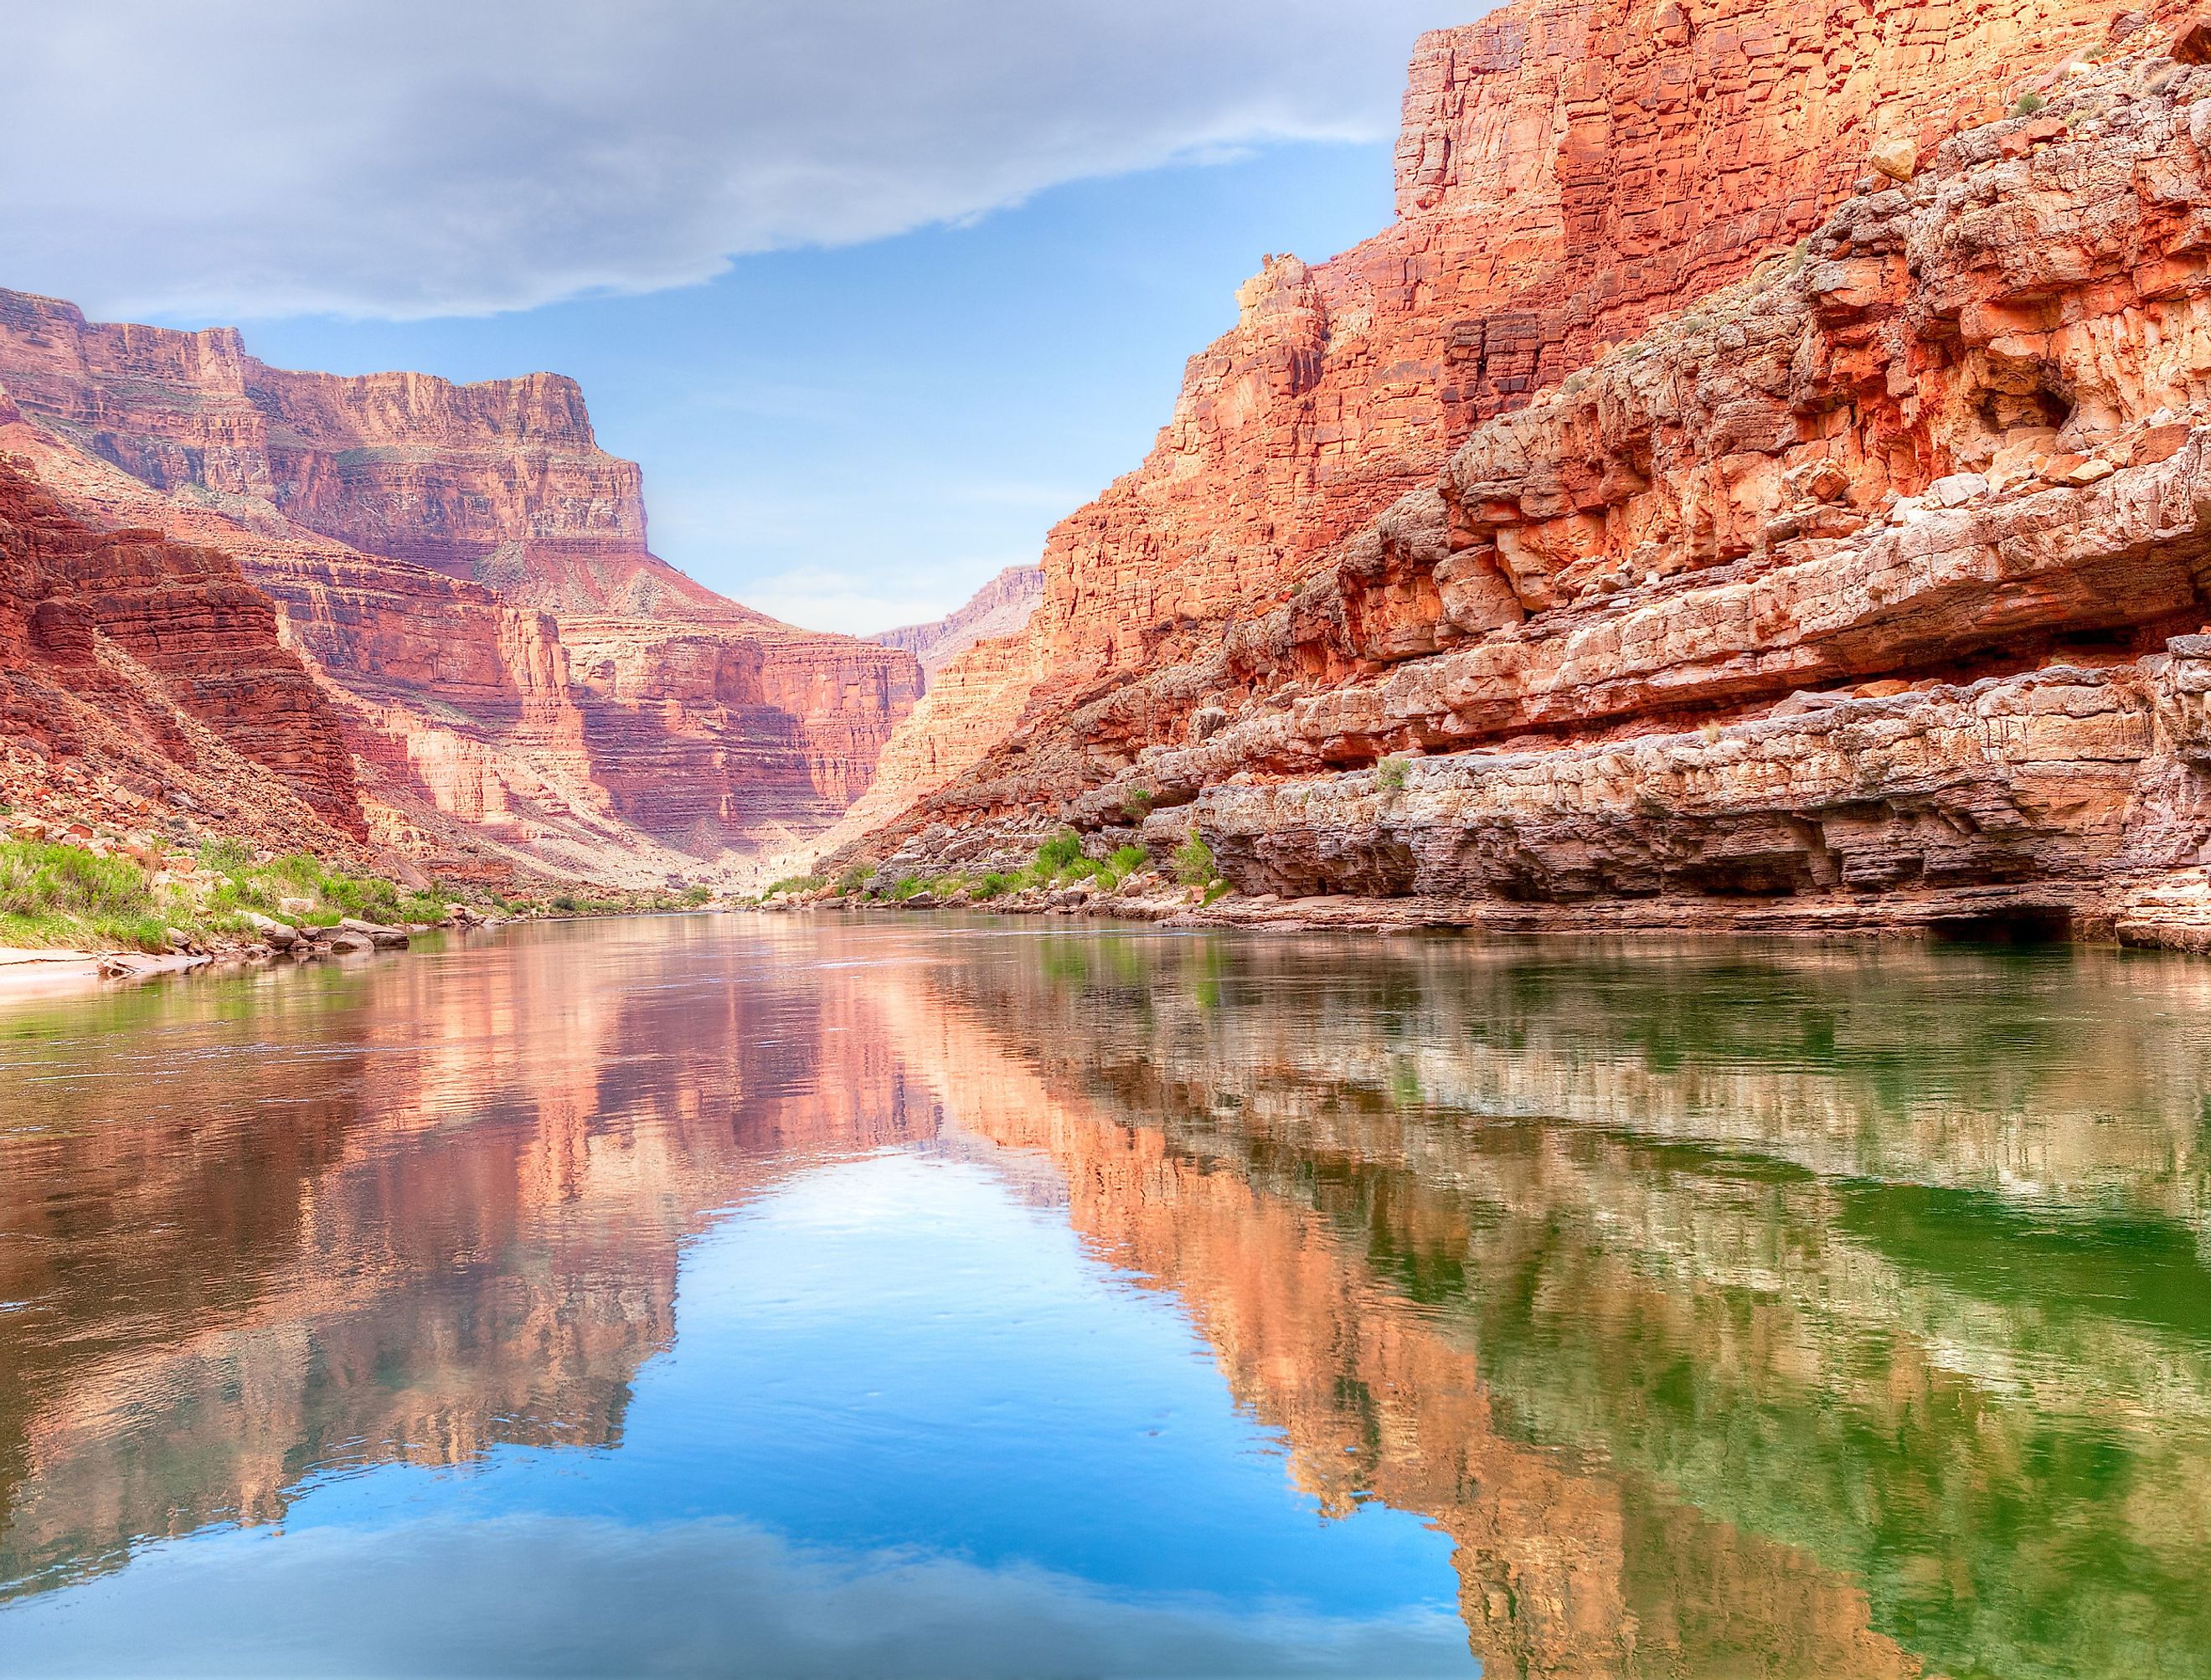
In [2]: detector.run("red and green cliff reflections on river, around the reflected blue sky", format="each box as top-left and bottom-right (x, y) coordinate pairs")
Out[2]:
(0, 920), (2211, 1676)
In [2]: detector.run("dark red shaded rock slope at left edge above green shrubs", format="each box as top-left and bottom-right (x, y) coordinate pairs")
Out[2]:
(0, 466), (367, 847)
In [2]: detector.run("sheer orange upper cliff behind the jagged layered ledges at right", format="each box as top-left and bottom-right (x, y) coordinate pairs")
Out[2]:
(1039, 0), (2149, 681)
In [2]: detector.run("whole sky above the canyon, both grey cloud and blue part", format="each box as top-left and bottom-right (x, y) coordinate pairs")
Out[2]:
(0, 0), (1488, 632)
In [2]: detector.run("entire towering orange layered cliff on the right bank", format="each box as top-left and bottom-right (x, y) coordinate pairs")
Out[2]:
(840, 4), (2211, 941)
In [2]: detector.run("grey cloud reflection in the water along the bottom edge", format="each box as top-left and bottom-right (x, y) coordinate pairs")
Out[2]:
(7, 1517), (1472, 1676)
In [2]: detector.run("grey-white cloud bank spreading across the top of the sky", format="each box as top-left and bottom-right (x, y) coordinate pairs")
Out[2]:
(17, 0), (1486, 318)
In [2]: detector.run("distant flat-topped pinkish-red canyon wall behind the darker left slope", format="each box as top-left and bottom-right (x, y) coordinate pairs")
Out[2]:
(0, 291), (920, 884)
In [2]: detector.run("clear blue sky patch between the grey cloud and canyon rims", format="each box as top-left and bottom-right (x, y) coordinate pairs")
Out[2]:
(229, 142), (1391, 632)
